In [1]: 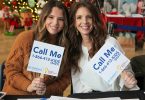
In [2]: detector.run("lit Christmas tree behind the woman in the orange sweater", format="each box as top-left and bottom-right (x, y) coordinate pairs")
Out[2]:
(3, 0), (48, 21)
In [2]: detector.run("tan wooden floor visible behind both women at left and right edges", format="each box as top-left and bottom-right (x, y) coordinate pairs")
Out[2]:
(0, 26), (145, 64)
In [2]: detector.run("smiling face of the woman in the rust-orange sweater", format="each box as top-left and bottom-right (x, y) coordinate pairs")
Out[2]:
(45, 7), (64, 35)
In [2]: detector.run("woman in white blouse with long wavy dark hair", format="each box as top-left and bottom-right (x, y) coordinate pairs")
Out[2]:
(66, 2), (138, 93)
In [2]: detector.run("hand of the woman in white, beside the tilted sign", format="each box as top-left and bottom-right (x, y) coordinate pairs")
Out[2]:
(122, 71), (137, 89)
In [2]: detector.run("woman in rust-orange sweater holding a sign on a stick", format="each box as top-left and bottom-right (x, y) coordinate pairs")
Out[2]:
(3, 0), (70, 95)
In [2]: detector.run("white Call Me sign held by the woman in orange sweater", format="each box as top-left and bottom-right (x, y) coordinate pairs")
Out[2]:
(27, 41), (64, 76)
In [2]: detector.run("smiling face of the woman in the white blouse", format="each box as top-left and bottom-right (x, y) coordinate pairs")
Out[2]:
(75, 7), (93, 37)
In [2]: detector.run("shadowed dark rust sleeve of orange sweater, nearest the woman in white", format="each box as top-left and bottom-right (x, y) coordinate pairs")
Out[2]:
(45, 72), (71, 96)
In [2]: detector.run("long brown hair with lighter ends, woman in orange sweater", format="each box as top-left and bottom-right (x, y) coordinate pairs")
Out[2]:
(34, 0), (69, 45)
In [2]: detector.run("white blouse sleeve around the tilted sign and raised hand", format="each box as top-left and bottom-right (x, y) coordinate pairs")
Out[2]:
(108, 37), (139, 91)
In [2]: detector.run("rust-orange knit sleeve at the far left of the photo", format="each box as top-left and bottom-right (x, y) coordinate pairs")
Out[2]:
(5, 32), (31, 91)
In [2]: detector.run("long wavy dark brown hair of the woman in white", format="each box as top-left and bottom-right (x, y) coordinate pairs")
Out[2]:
(67, 2), (108, 72)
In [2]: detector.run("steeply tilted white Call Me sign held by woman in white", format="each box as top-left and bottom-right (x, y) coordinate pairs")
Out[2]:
(81, 43), (130, 87)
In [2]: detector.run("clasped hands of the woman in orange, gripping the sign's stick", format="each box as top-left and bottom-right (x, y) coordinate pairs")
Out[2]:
(27, 78), (44, 92)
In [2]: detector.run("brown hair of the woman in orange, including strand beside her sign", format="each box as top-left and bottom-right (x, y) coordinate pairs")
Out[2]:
(34, 0), (69, 74)
